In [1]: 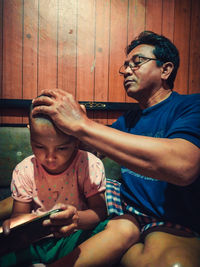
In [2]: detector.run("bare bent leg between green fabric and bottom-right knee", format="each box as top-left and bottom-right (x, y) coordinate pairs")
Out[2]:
(48, 214), (140, 267)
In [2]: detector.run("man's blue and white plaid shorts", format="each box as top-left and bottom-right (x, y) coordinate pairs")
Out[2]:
(106, 179), (199, 237)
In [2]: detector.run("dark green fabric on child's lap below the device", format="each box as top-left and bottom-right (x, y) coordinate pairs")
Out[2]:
(0, 218), (109, 267)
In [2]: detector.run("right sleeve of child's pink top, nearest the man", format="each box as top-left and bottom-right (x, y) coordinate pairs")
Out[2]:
(80, 152), (106, 198)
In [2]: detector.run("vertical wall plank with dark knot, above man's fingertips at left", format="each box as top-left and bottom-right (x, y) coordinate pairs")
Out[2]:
(23, 0), (38, 99)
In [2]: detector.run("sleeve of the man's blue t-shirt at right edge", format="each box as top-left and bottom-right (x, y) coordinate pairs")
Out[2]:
(166, 100), (200, 147)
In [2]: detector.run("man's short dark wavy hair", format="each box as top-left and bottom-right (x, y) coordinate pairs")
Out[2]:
(126, 31), (180, 89)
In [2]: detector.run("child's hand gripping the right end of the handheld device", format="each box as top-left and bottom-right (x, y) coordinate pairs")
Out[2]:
(43, 204), (79, 238)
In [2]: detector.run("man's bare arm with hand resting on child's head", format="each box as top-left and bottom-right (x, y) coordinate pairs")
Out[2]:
(33, 89), (200, 186)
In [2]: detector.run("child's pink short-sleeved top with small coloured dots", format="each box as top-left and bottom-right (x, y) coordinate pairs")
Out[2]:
(11, 150), (106, 214)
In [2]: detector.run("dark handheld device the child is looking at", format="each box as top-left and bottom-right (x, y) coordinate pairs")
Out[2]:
(0, 209), (61, 256)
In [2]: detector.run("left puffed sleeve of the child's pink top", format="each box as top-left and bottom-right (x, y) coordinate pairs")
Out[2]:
(11, 162), (33, 202)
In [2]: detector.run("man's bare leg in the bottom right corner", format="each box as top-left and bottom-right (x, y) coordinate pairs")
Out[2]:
(120, 232), (200, 267)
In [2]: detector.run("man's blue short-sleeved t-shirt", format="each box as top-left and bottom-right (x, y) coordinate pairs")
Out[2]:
(112, 92), (200, 233)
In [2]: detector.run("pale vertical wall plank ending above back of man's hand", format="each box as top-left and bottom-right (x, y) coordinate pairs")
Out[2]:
(58, 0), (77, 96)
